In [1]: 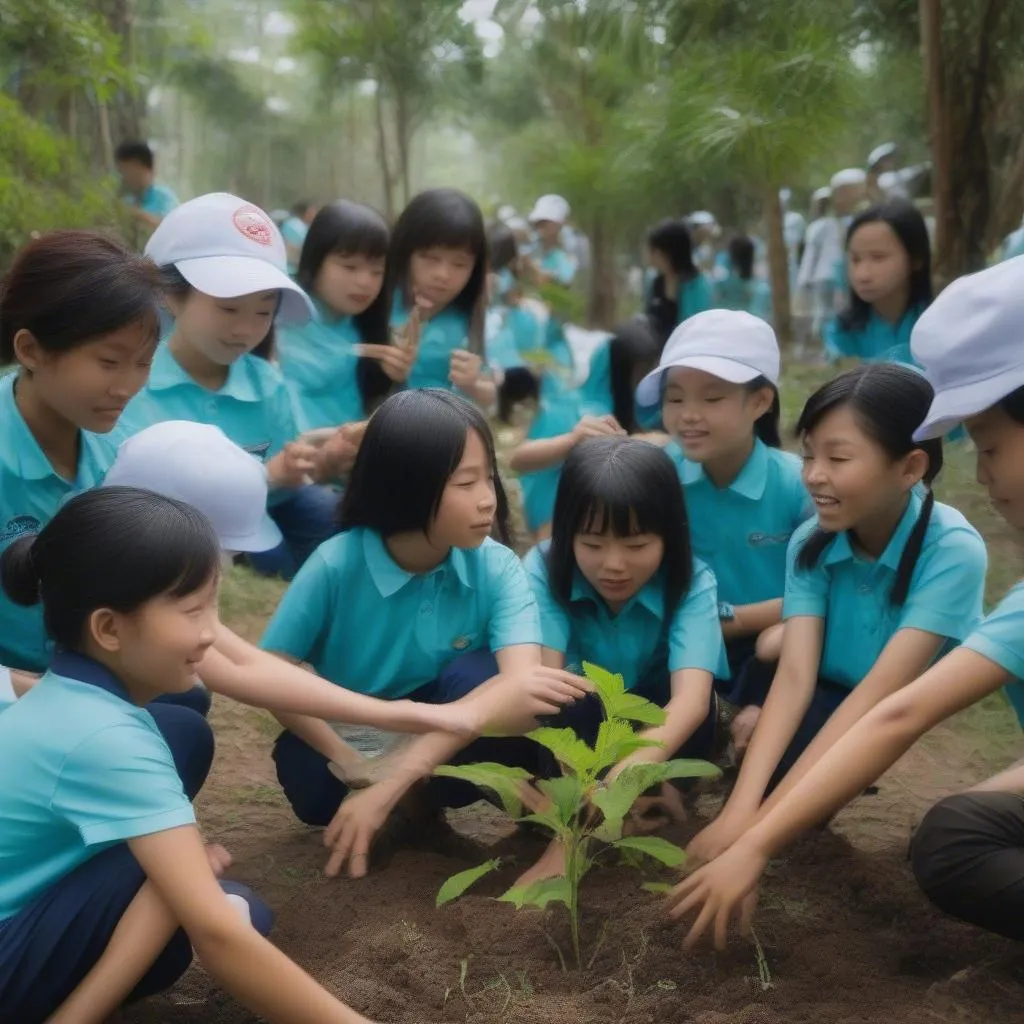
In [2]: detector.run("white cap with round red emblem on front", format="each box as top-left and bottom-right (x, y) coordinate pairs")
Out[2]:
(145, 193), (313, 325)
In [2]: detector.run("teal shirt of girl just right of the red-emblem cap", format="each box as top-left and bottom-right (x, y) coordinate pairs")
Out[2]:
(276, 306), (366, 430)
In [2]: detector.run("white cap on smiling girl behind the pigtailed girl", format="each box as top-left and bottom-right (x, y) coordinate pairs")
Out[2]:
(637, 309), (779, 407)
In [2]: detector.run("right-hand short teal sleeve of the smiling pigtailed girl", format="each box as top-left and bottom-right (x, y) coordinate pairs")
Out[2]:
(897, 528), (988, 640)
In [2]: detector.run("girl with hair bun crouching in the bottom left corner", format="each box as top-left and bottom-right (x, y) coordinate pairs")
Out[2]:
(0, 487), (365, 1024)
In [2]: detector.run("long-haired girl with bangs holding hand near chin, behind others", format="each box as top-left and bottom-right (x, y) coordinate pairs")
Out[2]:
(386, 188), (496, 409)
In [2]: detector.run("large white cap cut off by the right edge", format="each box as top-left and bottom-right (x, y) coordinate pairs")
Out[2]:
(910, 256), (1024, 440)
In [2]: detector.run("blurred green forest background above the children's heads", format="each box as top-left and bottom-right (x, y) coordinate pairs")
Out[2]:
(0, 0), (1024, 324)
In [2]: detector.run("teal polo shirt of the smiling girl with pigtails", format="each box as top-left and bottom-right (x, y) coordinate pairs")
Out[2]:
(782, 493), (988, 689)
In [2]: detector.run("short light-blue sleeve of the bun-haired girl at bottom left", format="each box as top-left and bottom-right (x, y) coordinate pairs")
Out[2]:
(52, 721), (196, 846)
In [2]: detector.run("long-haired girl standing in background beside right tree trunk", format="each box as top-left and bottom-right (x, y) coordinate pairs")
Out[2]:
(824, 199), (932, 362)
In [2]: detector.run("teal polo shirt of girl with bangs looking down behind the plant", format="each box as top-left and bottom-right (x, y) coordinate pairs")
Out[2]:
(524, 542), (729, 690)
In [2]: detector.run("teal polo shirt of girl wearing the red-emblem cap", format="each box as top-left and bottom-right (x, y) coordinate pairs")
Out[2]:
(124, 342), (299, 504)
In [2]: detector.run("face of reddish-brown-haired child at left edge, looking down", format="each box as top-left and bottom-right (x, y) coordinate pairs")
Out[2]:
(15, 321), (157, 434)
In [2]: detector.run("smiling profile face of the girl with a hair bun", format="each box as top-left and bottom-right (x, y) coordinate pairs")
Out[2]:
(96, 574), (220, 699)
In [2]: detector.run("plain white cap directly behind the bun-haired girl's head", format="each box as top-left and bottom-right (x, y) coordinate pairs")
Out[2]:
(103, 420), (282, 552)
